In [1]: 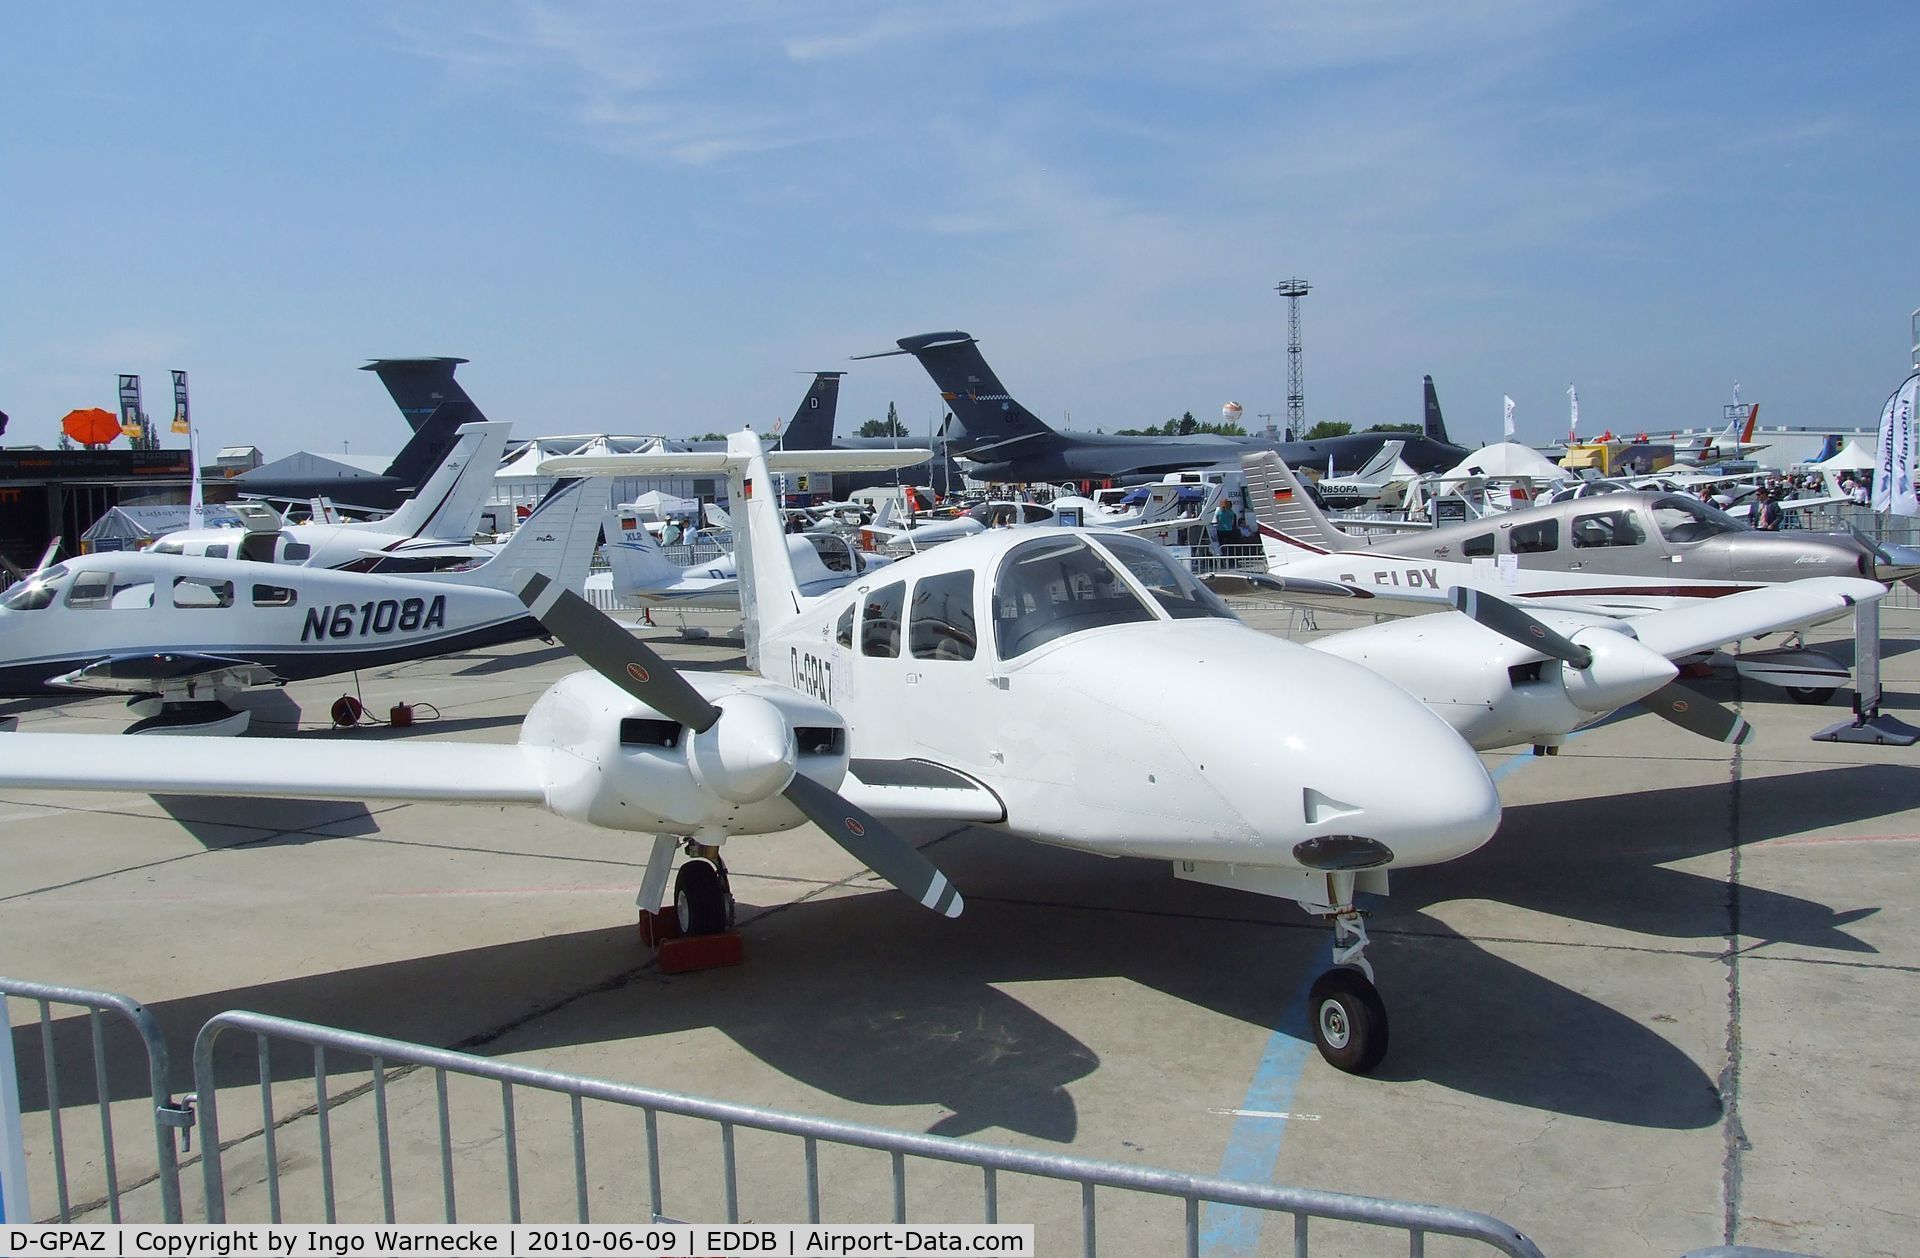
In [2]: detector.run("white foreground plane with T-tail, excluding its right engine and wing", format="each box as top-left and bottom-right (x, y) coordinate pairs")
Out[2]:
(0, 432), (1500, 1072)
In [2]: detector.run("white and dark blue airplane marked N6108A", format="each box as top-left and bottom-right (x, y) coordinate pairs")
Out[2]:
(0, 482), (605, 737)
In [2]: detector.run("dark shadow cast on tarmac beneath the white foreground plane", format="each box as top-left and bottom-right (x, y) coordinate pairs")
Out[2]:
(15, 766), (1910, 1141)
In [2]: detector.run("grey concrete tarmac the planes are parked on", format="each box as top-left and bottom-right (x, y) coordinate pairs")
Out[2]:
(0, 609), (1920, 1254)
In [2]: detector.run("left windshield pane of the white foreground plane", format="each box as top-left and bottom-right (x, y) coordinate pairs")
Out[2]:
(993, 536), (1156, 659)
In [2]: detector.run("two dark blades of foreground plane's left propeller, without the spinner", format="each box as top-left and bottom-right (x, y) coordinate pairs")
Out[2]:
(520, 576), (966, 918)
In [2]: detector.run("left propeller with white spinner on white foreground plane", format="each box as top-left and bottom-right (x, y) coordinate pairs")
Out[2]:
(520, 574), (966, 918)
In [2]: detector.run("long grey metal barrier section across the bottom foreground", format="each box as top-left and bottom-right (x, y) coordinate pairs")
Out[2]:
(194, 1012), (1540, 1258)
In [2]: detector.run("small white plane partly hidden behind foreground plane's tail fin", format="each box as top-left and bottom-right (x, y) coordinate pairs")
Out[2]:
(588, 511), (891, 611)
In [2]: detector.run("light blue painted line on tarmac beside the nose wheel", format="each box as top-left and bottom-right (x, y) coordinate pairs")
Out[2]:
(1200, 749), (1578, 1258)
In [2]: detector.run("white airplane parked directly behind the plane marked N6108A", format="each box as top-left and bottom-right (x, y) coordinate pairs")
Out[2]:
(148, 423), (513, 572)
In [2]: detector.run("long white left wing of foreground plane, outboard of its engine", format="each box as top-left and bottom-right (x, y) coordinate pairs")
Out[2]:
(0, 734), (547, 803)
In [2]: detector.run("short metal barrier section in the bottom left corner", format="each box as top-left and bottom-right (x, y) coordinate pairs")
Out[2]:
(0, 978), (194, 1223)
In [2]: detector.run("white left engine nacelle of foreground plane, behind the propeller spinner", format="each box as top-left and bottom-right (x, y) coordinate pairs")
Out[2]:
(520, 672), (847, 841)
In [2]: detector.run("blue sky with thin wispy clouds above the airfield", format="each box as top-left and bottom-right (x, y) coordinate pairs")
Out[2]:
(0, 0), (1920, 455)
